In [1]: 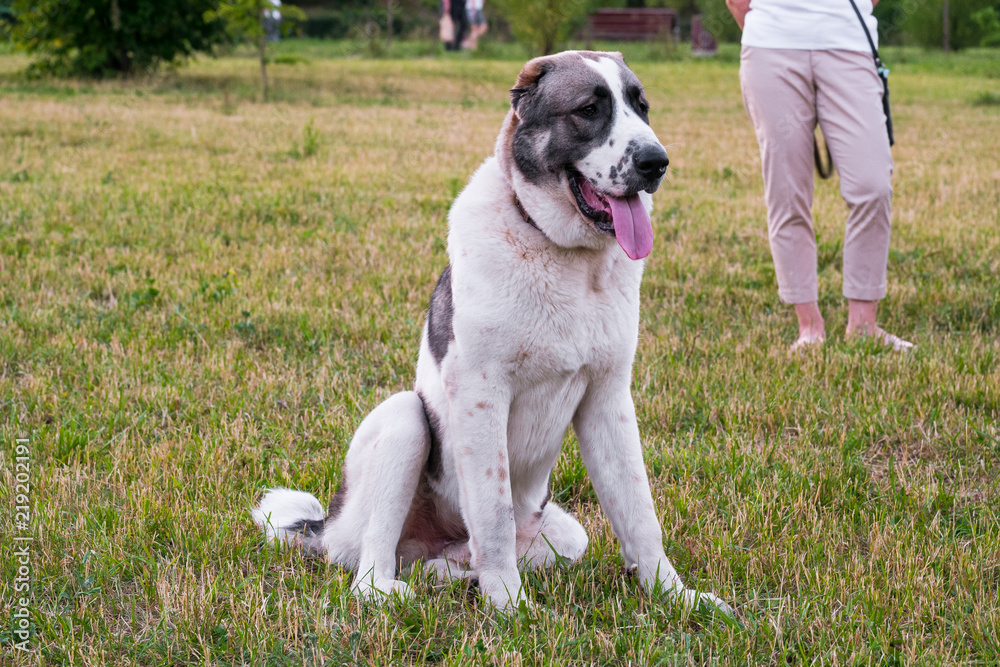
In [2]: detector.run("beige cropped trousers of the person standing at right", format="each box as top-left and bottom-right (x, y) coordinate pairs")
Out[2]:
(740, 46), (893, 304)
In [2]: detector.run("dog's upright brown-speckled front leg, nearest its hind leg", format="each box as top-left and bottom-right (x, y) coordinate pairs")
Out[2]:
(446, 369), (524, 609)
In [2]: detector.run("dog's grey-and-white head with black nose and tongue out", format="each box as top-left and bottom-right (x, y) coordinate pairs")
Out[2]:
(497, 51), (668, 259)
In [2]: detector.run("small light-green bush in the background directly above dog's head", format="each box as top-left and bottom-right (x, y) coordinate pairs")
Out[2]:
(493, 0), (596, 56)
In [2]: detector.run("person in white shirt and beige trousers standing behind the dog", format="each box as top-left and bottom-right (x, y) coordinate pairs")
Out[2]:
(726, 0), (913, 351)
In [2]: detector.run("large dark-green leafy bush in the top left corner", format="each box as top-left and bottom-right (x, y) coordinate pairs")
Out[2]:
(11, 0), (226, 76)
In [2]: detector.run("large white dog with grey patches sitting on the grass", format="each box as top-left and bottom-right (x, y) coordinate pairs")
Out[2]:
(252, 51), (731, 613)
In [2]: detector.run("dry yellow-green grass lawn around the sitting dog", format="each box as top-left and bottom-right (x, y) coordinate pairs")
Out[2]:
(0, 43), (1000, 665)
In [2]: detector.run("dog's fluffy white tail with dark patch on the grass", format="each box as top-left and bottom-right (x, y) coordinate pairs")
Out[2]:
(250, 488), (325, 555)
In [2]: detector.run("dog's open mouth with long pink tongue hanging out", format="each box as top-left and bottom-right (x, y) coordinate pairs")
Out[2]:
(566, 167), (653, 259)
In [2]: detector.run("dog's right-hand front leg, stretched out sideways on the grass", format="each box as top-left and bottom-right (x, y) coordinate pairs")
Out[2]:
(573, 377), (731, 613)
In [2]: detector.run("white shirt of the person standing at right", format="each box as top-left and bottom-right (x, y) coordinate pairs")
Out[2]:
(742, 0), (878, 53)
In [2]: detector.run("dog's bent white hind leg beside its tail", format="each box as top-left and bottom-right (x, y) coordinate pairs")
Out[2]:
(323, 392), (430, 598)
